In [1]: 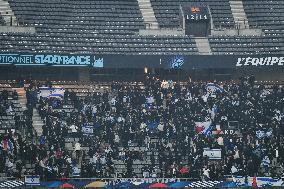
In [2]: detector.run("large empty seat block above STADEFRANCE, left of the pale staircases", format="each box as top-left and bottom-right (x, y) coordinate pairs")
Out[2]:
(1, 0), (198, 54)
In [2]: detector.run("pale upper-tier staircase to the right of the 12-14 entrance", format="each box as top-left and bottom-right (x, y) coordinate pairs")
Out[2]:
(230, 0), (249, 29)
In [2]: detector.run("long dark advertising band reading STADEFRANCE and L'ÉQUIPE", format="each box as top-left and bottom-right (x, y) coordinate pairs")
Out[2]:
(0, 53), (284, 70)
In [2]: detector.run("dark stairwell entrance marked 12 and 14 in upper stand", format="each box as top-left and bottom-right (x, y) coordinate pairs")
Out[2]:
(180, 4), (211, 37)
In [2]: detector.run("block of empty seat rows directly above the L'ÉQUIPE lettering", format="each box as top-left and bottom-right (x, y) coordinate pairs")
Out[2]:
(209, 36), (283, 55)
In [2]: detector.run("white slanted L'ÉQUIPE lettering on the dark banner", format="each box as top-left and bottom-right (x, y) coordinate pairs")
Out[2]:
(236, 57), (284, 67)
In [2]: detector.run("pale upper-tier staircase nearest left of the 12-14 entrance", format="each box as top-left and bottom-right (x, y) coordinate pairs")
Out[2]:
(138, 0), (159, 29)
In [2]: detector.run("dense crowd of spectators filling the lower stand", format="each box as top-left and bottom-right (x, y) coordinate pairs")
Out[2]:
(0, 77), (284, 180)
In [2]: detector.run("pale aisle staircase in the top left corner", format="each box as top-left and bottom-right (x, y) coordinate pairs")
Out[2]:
(0, 0), (18, 26)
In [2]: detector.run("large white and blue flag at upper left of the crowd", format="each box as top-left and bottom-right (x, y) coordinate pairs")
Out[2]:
(38, 87), (65, 99)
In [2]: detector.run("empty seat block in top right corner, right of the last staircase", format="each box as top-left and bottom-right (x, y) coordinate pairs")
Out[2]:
(243, 0), (284, 30)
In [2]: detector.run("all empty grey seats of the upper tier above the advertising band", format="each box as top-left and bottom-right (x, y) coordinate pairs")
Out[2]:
(0, 0), (284, 55)
